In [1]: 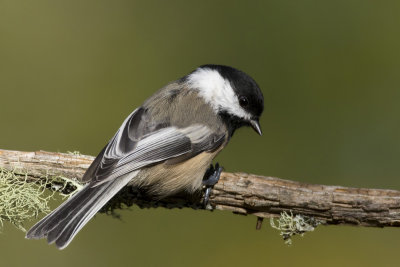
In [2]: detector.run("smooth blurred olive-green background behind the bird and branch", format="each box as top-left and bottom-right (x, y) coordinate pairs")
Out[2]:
(0, 0), (400, 267)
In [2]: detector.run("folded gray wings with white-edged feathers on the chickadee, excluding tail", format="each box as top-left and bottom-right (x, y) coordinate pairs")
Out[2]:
(83, 107), (225, 186)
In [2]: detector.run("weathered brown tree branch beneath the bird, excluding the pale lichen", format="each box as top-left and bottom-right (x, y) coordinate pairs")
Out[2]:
(0, 149), (400, 227)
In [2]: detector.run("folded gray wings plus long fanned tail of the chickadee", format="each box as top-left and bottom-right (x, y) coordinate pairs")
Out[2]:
(26, 105), (225, 249)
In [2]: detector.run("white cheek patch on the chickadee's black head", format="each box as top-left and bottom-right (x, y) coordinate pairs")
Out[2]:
(188, 68), (251, 119)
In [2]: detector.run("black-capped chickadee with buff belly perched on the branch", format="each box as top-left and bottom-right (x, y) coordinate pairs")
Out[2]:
(26, 65), (264, 249)
